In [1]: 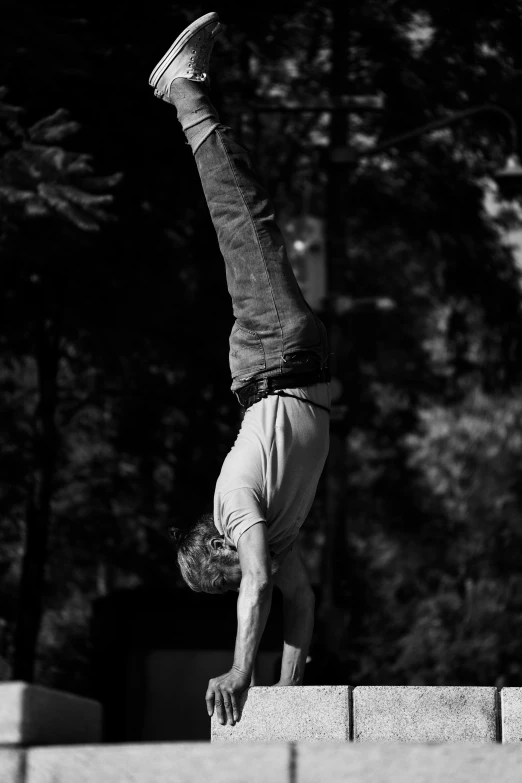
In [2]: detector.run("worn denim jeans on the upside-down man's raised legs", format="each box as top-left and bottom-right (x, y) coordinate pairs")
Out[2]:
(195, 125), (328, 391)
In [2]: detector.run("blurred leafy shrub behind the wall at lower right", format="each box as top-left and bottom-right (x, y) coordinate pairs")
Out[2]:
(394, 390), (522, 685)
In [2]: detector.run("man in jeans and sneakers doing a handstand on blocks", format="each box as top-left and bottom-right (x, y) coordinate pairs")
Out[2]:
(149, 13), (330, 725)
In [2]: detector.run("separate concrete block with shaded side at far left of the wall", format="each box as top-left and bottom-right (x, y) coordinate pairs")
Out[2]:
(0, 682), (102, 745)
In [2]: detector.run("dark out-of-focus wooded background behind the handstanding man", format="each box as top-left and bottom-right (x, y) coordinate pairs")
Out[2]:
(0, 0), (522, 694)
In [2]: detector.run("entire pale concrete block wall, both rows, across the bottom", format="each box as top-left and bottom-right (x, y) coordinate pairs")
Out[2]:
(5, 683), (522, 783)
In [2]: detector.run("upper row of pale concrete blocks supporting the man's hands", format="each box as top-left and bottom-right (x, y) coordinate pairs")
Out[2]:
(211, 685), (522, 744)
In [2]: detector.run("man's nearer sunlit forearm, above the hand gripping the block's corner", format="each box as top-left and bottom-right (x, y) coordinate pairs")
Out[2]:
(233, 577), (272, 676)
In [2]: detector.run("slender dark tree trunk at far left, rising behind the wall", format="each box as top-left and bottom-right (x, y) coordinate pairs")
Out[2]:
(13, 322), (58, 682)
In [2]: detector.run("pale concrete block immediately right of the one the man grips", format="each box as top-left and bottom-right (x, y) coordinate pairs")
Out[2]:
(353, 685), (497, 742)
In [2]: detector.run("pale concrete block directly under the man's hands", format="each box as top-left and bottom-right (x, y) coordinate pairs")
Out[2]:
(211, 685), (350, 742)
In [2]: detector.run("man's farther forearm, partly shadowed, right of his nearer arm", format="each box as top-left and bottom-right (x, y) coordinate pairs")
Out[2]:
(279, 593), (314, 685)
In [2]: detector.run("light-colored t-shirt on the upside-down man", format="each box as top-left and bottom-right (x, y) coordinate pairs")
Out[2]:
(214, 383), (330, 556)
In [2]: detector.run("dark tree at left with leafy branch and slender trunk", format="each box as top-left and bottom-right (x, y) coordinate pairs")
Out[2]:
(0, 90), (120, 681)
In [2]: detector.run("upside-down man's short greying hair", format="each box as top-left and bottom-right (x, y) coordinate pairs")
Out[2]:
(170, 514), (241, 593)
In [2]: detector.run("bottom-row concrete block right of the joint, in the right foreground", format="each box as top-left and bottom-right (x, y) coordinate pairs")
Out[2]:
(295, 743), (522, 783)
